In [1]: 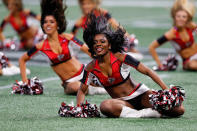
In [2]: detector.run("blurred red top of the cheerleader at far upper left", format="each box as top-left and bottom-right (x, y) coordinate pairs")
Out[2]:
(1, 11), (29, 33)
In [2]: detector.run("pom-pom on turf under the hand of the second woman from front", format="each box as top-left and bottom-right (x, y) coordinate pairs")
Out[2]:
(12, 77), (43, 95)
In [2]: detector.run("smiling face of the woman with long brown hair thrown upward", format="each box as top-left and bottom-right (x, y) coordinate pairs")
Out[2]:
(43, 15), (57, 35)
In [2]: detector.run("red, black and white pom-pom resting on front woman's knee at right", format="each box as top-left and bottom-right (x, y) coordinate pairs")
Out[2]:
(149, 86), (185, 112)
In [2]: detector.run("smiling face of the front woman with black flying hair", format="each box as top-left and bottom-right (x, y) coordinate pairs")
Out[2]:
(93, 34), (110, 56)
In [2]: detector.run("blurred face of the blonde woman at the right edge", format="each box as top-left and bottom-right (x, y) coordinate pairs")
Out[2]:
(174, 10), (188, 27)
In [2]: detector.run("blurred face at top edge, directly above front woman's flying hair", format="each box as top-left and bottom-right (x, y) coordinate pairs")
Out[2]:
(80, 0), (96, 15)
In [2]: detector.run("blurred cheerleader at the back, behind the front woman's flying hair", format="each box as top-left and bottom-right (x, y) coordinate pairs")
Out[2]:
(72, 0), (143, 60)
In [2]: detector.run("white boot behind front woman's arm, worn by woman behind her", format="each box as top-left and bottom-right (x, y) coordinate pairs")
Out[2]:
(88, 85), (107, 95)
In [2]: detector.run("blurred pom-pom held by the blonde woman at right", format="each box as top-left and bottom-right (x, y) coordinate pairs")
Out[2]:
(153, 54), (178, 71)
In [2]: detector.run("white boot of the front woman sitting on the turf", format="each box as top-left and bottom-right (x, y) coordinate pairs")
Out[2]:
(120, 106), (161, 118)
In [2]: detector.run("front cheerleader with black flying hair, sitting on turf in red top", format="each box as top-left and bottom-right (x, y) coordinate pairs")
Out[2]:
(77, 13), (185, 118)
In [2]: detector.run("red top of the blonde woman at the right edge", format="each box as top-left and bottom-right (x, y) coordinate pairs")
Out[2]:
(172, 28), (194, 50)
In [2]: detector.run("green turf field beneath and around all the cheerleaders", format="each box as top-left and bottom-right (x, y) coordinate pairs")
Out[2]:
(0, 0), (197, 131)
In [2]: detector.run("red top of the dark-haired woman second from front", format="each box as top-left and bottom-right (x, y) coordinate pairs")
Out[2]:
(27, 35), (83, 66)
